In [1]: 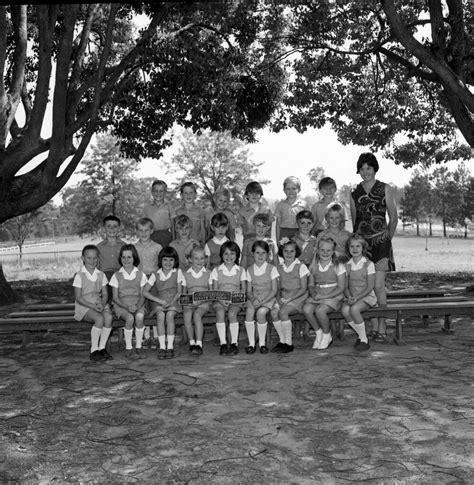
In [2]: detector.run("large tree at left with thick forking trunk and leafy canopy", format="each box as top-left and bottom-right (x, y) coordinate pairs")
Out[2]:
(0, 2), (282, 299)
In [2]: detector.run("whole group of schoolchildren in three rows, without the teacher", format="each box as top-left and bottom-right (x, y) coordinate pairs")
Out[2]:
(73, 177), (377, 361)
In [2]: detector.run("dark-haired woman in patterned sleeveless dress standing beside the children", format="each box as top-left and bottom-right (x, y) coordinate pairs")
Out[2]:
(350, 153), (398, 343)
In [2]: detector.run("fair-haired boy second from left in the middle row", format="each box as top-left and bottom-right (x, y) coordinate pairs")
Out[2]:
(135, 217), (162, 348)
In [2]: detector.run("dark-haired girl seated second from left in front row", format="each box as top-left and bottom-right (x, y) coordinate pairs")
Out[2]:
(110, 244), (147, 359)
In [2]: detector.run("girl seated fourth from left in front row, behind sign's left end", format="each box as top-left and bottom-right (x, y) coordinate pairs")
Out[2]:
(183, 246), (211, 355)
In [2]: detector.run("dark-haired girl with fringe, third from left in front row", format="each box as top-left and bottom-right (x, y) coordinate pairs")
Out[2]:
(143, 246), (184, 359)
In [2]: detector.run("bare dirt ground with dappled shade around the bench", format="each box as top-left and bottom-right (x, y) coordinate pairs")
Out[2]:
(0, 275), (474, 484)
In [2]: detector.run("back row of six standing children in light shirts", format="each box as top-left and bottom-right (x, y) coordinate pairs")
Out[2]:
(143, 177), (345, 247)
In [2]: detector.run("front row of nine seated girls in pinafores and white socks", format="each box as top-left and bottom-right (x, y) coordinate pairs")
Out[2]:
(73, 214), (376, 361)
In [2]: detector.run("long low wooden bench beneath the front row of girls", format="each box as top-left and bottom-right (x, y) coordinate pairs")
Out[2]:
(0, 295), (474, 346)
